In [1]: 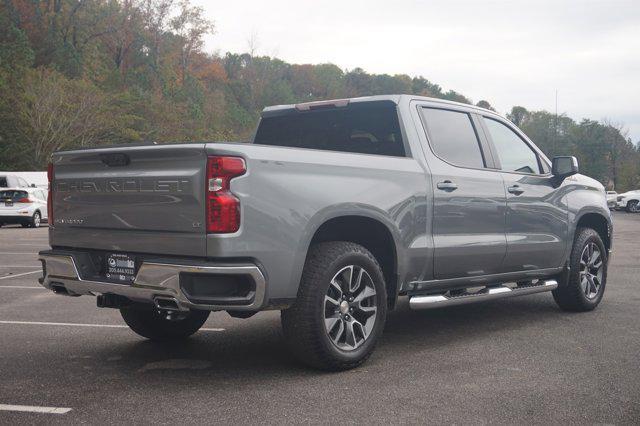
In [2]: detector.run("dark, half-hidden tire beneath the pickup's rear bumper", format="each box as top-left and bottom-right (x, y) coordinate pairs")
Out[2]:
(120, 306), (209, 341)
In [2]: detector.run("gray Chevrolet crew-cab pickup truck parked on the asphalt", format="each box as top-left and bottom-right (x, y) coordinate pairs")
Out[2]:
(40, 95), (612, 370)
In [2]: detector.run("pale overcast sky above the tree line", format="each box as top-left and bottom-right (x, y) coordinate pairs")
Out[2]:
(194, 0), (640, 142)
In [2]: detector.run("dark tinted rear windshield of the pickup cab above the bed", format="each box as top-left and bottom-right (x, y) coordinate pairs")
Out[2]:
(254, 102), (405, 157)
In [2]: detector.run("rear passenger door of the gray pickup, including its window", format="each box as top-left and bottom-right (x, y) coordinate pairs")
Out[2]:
(418, 104), (506, 279)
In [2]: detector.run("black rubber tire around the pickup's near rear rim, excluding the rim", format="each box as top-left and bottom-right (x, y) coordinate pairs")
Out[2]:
(281, 241), (387, 371)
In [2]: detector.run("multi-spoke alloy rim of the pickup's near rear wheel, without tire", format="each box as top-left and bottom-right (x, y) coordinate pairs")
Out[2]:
(323, 265), (377, 351)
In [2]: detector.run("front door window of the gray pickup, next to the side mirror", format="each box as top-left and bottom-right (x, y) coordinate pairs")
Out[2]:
(483, 117), (540, 174)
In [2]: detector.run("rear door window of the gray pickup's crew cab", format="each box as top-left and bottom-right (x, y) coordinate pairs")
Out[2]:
(422, 108), (485, 168)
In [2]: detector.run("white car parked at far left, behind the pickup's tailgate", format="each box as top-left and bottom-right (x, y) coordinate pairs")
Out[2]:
(0, 188), (48, 228)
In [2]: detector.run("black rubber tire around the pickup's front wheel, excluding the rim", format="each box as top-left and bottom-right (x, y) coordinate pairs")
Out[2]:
(553, 228), (609, 312)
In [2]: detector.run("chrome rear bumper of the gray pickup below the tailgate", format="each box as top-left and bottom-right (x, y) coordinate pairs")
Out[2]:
(39, 251), (266, 311)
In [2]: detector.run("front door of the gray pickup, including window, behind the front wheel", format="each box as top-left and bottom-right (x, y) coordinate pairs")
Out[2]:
(479, 116), (569, 272)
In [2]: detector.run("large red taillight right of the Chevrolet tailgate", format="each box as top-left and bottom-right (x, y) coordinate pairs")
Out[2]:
(206, 156), (247, 233)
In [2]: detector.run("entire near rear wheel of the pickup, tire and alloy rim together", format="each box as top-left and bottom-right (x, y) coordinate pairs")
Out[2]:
(281, 241), (387, 371)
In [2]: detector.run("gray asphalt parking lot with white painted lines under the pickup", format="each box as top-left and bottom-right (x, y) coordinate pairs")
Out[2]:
(0, 213), (640, 424)
